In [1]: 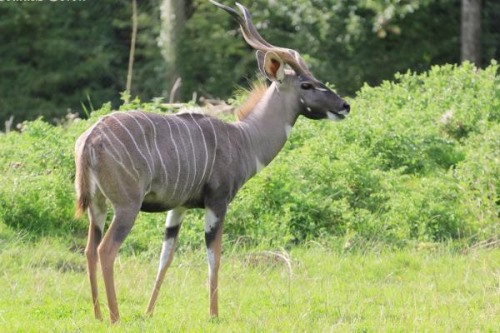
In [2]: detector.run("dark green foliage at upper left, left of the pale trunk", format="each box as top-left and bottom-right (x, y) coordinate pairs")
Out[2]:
(0, 0), (163, 127)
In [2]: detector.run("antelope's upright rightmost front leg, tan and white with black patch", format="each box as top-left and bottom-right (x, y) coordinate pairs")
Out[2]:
(205, 207), (226, 317)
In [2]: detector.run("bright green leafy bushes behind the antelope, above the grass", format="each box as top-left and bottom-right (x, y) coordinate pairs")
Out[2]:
(0, 63), (500, 253)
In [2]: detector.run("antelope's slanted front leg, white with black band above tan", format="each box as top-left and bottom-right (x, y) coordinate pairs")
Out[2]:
(146, 208), (185, 315)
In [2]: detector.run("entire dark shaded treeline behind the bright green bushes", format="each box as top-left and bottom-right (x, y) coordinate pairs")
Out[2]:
(0, 0), (500, 127)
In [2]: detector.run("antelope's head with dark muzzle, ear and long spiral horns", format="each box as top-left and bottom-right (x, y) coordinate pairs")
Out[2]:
(210, 0), (350, 121)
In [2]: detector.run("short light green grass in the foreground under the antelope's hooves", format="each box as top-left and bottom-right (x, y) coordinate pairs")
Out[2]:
(0, 233), (500, 332)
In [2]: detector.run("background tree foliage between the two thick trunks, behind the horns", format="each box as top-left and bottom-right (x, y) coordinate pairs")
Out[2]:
(179, 0), (460, 98)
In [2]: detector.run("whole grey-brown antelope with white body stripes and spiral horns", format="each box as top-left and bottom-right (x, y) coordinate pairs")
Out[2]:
(75, 0), (350, 322)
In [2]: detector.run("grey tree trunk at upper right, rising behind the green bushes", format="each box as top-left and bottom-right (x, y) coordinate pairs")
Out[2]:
(461, 0), (481, 67)
